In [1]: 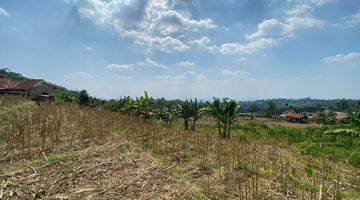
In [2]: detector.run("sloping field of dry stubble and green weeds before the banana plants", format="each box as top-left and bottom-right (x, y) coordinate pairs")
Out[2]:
(0, 97), (360, 199)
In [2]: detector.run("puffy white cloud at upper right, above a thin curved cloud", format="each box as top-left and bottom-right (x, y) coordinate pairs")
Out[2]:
(245, 17), (324, 40)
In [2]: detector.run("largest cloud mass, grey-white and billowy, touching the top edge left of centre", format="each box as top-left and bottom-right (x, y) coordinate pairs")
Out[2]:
(66, 0), (216, 52)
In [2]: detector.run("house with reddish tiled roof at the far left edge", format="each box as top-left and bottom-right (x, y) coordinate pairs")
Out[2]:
(0, 75), (59, 99)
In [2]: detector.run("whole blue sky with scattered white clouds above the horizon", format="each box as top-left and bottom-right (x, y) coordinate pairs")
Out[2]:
(0, 0), (360, 100)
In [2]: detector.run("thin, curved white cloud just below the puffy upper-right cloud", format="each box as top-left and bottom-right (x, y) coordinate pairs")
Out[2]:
(189, 37), (278, 55)
